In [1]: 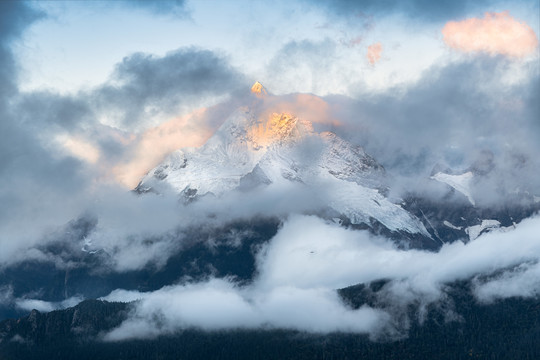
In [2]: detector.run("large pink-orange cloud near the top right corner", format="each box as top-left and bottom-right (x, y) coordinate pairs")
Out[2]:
(442, 11), (538, 57)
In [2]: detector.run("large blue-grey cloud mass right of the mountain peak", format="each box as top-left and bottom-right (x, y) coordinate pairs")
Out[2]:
(324, 56), (540, 202)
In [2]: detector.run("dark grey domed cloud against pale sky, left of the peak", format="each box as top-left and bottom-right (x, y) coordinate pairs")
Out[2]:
(89, 48), (247, 129)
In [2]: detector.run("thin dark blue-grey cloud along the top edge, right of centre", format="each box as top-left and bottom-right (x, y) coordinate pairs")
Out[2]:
(309, 0), (516, 22)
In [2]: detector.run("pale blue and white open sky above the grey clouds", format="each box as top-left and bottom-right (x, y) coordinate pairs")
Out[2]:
(16, 1), (538, 95)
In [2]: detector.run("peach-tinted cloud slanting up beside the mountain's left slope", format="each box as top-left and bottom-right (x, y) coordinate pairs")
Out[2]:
(113, 109), (212, 188)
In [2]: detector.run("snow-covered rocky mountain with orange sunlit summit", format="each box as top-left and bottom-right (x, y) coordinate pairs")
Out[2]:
(136, 83), (430, 237)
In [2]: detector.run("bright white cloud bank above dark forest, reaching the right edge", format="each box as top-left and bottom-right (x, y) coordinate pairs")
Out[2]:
(104, 216), (540, 341)
